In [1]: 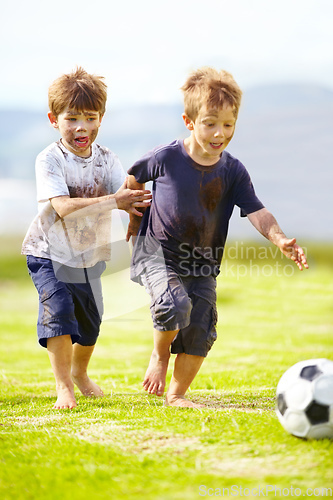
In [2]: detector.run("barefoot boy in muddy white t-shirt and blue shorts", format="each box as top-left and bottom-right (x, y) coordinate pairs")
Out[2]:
(22, 68), (151, 409)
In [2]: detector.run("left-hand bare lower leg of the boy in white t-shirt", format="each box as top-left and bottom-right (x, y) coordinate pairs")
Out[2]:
(47, 335), (77, 409)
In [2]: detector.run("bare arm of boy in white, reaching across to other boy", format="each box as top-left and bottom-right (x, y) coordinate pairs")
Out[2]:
(50, 178), (151, 218)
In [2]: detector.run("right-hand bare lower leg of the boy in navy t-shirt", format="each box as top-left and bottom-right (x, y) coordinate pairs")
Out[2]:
(165, 353), (205, 408)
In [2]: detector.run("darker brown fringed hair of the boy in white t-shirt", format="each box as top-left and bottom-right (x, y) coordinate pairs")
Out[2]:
(49, 67), (107, 117)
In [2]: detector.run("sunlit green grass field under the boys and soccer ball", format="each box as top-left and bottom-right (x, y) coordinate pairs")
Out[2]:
(0, 240), (333, 500)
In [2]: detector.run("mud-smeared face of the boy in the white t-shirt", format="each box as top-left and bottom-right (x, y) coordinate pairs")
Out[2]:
(48, 109), (102, 158)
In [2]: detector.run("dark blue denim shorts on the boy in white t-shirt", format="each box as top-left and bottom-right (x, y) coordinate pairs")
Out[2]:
(27, 255), (105, 347)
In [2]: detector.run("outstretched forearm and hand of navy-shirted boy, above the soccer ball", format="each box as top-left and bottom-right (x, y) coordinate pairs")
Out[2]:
(247, 208), (309, 271)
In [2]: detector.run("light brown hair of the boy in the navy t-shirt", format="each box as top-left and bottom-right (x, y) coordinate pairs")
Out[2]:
(181, 67), (242, 121)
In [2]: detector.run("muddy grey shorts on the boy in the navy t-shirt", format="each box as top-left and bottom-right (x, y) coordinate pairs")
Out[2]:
(141, 268), (217, 357)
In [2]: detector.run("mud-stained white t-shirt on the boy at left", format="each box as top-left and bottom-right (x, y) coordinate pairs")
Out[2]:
(22, 141), (125, 268)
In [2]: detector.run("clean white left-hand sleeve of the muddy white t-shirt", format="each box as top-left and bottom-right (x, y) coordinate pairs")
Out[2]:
(35, 152), (69, 202)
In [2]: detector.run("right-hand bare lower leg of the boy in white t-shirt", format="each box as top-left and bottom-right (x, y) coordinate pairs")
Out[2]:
(72, 344), (104, 397)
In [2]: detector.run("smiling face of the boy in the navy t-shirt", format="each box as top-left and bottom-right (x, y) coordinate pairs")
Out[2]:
(183, 106), (236, 165)
